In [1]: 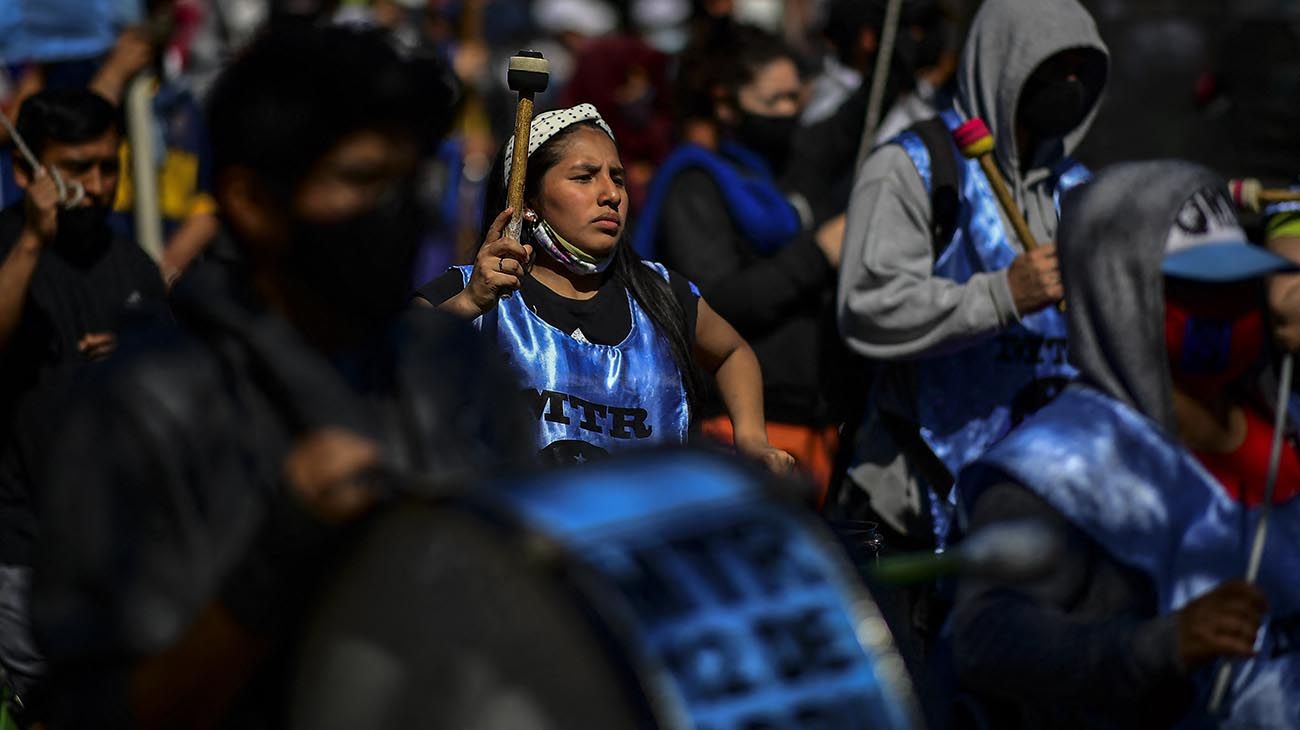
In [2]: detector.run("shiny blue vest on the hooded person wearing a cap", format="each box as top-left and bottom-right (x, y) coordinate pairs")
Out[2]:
(961, 384), (1300, 729)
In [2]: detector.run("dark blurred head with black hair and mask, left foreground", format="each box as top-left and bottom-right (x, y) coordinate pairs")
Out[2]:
(208, 23), (452, 349)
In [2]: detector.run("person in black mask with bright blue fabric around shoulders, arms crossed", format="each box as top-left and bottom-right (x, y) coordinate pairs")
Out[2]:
(633, 25), (844, 490)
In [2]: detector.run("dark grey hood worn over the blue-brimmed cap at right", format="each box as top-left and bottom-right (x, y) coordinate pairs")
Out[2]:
(1058, 160), (1290, 433)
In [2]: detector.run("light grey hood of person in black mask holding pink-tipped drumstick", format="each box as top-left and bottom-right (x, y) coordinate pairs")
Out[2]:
(957, 0), (1110, 178)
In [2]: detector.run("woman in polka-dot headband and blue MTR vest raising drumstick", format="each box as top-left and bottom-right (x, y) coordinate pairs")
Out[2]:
(417, 104), (793, 472)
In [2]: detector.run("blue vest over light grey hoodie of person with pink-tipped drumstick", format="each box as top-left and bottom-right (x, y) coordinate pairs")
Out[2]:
(892, 110), (1089, 474)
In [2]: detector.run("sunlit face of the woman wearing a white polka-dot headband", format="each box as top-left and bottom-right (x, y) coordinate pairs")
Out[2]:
(533, 127), (628, 258)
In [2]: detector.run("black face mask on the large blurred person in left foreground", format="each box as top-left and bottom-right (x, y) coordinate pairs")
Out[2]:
(289, 185), (425, 329)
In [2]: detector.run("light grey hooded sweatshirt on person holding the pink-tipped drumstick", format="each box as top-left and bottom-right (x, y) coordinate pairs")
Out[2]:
(836, 0), (1106, 533)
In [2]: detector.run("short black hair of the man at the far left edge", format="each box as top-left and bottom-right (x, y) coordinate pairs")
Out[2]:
(13, 88), (122, 174)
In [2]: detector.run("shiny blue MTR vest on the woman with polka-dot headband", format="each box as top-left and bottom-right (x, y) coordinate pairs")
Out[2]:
(456, 262), (690, 454)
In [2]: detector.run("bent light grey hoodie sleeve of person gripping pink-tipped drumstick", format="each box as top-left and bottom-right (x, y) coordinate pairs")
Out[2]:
(836, 144), (1018, 360)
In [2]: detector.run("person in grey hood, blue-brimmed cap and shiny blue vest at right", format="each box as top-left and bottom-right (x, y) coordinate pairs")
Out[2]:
(952, 161), (1300, 727)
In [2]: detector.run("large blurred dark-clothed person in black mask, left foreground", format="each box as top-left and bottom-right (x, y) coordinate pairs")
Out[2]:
(33, 23), (523, 727)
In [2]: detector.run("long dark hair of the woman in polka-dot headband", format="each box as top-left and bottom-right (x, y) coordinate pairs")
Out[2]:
(478, 120), (703, 413)
